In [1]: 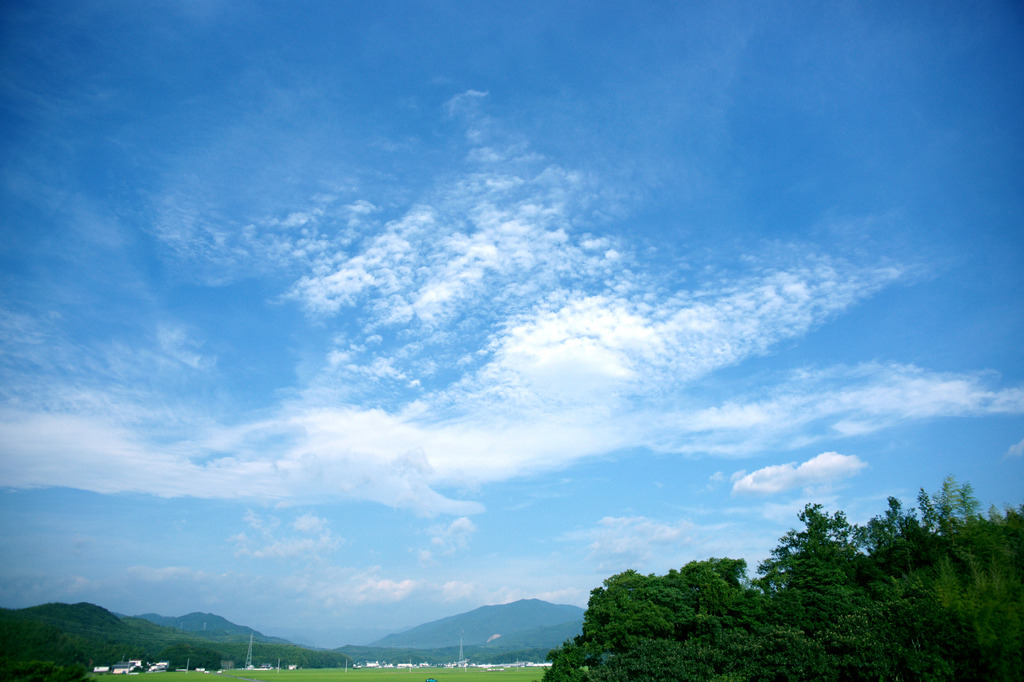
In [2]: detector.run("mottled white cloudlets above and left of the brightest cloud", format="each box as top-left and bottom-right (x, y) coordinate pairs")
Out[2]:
(290, 162), (607, 325)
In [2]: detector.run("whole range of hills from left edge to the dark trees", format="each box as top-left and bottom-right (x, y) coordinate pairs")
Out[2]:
(0, 599), (584, 669)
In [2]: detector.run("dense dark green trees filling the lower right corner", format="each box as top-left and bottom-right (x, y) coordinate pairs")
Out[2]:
(544, 477), (1024, 682)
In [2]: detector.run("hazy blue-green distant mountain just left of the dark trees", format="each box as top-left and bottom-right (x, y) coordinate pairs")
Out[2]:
(371, 599), (584, 649)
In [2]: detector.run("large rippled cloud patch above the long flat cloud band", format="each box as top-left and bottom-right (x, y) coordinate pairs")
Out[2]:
(146, 91), (905, 419)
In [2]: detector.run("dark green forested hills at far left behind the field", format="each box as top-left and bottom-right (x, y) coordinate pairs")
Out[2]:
(0, 603), (348, 667)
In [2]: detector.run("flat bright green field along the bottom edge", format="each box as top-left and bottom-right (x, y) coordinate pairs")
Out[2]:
(152, 668), (545, 682)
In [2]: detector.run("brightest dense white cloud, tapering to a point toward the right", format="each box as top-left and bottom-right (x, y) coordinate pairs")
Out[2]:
(458, 259), (900, 411)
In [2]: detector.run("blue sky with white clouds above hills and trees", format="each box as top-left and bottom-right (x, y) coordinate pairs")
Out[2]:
(0, 0), (1024, 646)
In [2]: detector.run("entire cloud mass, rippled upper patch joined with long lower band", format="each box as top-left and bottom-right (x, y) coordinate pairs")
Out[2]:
(0, 93), (1024, 516)
